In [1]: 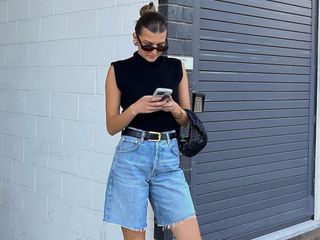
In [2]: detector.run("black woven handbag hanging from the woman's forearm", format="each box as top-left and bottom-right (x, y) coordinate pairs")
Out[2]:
(178, 109), (208, 157)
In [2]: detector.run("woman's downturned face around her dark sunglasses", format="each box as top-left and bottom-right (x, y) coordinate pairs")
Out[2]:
(133, 28), (167, 62)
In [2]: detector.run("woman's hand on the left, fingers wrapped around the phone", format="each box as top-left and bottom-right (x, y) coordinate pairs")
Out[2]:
(130, 95), (166, 115)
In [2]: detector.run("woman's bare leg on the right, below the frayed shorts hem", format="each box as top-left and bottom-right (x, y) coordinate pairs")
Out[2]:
(171, 218), (201, 240)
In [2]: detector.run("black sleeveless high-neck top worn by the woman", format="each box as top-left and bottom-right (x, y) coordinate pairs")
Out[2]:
(111, 51), (182, 132)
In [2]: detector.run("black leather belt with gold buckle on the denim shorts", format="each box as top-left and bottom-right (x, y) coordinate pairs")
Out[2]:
(121, 128), (176, 142)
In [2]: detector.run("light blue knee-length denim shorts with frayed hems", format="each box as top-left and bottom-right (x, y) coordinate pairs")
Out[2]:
(103, 132), (196, 231)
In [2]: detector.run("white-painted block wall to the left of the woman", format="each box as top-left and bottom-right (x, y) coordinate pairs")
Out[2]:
(0, 0), (153, 240)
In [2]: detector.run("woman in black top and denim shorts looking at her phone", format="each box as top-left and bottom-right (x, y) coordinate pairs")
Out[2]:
(103, 2), (201, 240)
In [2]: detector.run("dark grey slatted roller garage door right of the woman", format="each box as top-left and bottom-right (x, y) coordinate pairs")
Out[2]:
(191, 0), (317, 240)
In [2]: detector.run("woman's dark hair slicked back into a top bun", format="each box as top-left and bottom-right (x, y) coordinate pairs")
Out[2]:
(135, 2), (168, 35)
